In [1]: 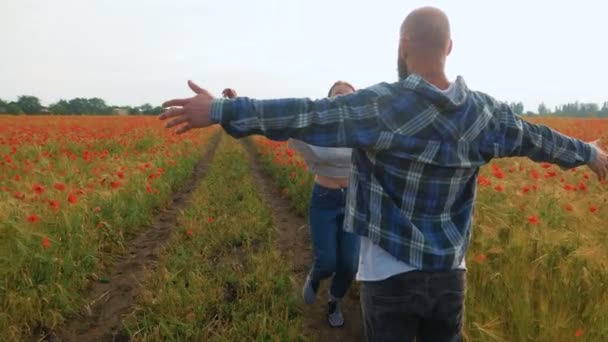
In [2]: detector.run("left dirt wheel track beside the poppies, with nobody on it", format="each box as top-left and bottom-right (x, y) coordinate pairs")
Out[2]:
(45, 134), (222, 342)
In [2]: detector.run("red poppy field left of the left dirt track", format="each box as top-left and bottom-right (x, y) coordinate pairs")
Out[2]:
(0, 117), (218, 341)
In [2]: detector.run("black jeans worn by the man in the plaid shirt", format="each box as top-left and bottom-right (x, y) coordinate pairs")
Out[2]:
(361, 270), (466, 342)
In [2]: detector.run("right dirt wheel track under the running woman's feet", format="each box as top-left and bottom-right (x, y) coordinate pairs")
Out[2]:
(243, 142), (364, 342)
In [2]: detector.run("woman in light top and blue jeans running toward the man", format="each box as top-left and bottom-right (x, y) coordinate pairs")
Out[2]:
(223, 81), (359, 327)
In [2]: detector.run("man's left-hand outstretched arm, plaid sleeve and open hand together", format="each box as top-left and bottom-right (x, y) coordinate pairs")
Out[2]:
(160, 82), (391, 147)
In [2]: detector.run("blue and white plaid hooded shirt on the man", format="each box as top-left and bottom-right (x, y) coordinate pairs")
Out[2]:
(211, 75), (597, 271)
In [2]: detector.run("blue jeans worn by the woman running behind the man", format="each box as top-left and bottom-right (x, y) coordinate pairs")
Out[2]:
(309, 183), (359, 298)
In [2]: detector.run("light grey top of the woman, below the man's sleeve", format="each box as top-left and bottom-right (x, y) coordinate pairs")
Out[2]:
(288, 139), (352, 178)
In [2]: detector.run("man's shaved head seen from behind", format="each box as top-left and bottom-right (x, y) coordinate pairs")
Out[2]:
(397, 7), (452, 79)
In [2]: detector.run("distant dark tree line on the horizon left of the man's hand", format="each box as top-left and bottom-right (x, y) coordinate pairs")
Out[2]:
(0, 95), (162, 115)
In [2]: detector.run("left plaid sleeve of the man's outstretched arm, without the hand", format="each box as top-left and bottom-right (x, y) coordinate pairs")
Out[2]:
(211, 90), (388, 147)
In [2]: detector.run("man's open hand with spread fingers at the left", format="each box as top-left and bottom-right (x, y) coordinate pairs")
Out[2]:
(158, 81), (213, 134)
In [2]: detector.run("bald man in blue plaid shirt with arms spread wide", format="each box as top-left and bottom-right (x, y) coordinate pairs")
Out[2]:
(160, 7), (608, 341)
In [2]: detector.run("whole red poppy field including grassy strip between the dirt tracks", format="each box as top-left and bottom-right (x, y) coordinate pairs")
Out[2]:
(0, 116), (608, 341)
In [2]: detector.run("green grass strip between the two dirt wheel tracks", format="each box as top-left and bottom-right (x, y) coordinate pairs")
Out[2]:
(124, 139), (303, 341)
